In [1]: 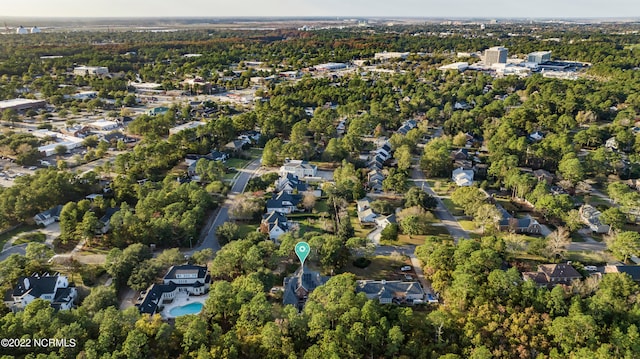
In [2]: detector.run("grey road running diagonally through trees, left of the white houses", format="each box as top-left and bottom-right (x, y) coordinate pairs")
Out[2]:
(185, 160), (260, 256)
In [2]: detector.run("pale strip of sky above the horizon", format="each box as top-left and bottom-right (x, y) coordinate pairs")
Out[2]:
(1, 0), (640, 18)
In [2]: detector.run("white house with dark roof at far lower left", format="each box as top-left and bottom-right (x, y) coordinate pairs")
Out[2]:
(7, 273), (78, 310)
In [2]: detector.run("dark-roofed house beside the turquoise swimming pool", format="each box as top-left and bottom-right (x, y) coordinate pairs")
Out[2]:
(136, 264), (211, 315)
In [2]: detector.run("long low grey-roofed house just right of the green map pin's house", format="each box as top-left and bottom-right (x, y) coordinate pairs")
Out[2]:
(356, 280), (425, 304)
